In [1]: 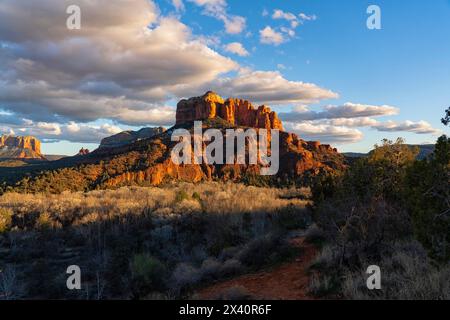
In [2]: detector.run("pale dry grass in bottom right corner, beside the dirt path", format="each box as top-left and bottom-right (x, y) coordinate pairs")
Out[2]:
(309, 241), (450, 300)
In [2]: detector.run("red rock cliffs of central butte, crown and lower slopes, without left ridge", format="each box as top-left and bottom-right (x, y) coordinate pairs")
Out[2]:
(96, 92), (344, 187)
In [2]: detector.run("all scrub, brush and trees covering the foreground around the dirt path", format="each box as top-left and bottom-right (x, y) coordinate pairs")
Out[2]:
(0, 136), (450, 299)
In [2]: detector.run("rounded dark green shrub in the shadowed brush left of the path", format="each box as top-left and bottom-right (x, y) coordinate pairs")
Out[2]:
(130, 254), (167, 297)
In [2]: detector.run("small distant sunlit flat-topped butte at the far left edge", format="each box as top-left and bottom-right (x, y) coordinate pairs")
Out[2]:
(0, 135), (44, 159)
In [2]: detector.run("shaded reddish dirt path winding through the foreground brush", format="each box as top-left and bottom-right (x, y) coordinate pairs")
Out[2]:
(197, 232), (317, 300)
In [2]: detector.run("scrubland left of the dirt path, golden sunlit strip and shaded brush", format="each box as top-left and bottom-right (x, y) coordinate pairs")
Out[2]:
(0, 183), (311, 299)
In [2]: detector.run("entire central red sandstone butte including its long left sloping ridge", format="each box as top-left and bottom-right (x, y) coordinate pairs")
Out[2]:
(6, 92), (345, 192)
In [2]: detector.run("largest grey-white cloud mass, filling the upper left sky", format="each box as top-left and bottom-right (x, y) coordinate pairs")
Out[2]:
(0, 0), (239, 130)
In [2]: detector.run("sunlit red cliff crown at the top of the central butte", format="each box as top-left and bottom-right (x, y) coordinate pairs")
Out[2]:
(176, 91), (283, 130)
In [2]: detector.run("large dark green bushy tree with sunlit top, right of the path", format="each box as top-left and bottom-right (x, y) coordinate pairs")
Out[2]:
(315, 138), (417, 251)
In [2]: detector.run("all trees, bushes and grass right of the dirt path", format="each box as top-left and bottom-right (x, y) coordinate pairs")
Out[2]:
(308, 136), (450, 299)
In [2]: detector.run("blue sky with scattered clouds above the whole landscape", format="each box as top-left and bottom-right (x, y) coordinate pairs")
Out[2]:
(0, 0), (450, 154)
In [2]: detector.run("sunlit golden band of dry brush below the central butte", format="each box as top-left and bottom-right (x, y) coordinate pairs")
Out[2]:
(0, 182), (308, 227)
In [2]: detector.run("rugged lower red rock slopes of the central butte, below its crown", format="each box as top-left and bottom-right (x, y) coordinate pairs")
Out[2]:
(98, 127), (344, 187)
